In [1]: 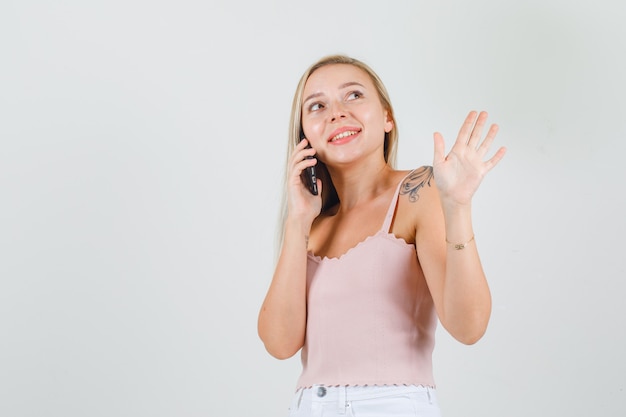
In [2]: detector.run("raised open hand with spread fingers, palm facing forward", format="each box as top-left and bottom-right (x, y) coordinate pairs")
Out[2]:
(433, 111), (506, 205)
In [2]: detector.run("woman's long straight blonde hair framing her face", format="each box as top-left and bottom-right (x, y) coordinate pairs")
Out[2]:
(277, 55), (398, 248)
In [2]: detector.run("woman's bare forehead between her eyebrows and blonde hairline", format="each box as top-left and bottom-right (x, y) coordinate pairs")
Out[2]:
(304, 64), (374, 96)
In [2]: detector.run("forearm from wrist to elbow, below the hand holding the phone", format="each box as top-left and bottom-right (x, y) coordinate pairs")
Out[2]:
(258, 219), (310, 359)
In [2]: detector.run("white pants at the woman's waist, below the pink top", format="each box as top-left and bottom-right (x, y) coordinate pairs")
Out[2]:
(289, 385), (441, 417)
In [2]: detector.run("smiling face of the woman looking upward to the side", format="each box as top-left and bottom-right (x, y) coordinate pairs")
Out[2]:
(302, 64), (393, 165)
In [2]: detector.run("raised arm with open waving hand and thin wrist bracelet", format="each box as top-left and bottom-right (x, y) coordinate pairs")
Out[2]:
(415, 112), (505, 344)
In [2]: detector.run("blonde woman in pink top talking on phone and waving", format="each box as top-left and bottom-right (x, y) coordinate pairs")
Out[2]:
(258, 56), (505, 416)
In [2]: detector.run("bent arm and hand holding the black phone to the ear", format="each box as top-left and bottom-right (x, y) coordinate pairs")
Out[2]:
(258, 141), (321, 359)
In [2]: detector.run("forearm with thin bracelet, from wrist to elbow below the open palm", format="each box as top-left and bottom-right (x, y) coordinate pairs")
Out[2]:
(442, 206), (491, 344)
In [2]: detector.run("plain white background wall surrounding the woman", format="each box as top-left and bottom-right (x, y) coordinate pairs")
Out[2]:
(0, 0), (626, 417)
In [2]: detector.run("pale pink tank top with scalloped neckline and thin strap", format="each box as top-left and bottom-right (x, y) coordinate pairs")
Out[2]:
(297, 170), (437, 388)
